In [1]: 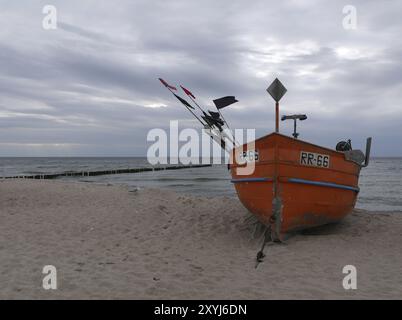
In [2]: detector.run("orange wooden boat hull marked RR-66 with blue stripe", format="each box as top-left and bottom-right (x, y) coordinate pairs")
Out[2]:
(230, 133), (361, 239)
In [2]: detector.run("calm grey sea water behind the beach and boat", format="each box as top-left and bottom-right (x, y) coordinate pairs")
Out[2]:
(0, 158), (402, 211)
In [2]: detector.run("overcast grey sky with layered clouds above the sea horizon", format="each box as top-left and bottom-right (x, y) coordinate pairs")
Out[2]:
(0, 0), (402, 156)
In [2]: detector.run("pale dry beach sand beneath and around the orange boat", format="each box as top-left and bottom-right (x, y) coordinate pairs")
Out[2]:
(0, 180), (402, 299)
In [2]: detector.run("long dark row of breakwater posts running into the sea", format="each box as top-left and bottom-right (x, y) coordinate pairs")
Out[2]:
(3, 164), (212, 179)
